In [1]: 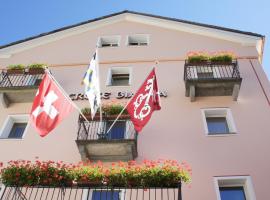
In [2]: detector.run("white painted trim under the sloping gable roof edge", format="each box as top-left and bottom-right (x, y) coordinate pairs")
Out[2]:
(0, 13), (262, 58)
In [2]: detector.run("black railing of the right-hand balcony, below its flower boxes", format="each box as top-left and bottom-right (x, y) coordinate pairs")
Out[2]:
(184, 60), (241, 81)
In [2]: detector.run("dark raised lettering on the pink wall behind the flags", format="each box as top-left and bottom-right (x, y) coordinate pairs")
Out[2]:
(69, 91), (168, 101)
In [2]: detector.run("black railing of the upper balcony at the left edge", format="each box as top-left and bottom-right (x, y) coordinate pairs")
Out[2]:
(0, 71), (44, 89)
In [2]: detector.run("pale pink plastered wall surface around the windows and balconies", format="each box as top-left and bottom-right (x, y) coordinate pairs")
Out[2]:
(0, 22), (270, 199)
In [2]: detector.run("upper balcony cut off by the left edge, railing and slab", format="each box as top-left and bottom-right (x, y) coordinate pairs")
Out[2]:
(0, 70), (43, 108)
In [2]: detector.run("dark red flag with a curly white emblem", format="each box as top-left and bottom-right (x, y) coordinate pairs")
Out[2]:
(127, 68), (161, 132)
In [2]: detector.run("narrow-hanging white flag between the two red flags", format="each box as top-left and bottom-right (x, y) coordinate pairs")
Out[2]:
(83, 51), (101, 119)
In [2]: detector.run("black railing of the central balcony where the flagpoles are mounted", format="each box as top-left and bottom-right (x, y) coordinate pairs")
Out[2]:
(77, 116), (137, 140)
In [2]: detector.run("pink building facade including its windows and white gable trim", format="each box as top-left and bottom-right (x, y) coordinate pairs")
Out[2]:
(0, 11), (270, 200)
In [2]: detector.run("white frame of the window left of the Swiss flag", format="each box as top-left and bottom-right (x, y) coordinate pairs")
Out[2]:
(0, 114), (29, 140)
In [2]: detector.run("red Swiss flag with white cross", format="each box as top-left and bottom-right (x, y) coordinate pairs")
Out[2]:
(30, 72), (73, 137)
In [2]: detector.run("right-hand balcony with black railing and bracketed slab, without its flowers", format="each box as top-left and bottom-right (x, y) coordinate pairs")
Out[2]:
(184, 60), (242, 101)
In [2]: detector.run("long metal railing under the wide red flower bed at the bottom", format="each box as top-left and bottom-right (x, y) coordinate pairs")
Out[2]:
(0, 184), (182, 200)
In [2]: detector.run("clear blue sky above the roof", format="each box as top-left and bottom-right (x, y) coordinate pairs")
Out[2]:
(0, 0), (270, 77)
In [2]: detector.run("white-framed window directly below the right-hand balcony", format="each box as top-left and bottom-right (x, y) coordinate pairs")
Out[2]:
(202, 108), (236, 135)
